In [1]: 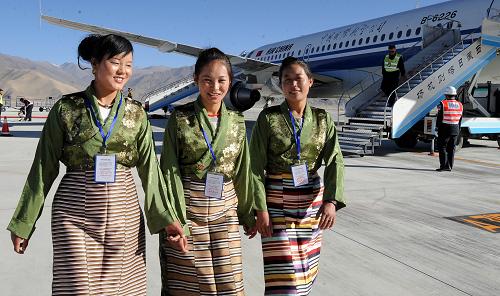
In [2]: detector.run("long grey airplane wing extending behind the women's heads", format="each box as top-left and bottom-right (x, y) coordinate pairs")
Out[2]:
(42, 15), (279, 72)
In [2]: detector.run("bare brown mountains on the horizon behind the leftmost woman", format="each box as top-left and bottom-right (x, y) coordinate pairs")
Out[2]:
(0, 53), (194, 100)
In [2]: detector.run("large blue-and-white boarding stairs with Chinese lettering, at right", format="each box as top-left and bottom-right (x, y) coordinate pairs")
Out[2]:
(338, 19), (500, 155)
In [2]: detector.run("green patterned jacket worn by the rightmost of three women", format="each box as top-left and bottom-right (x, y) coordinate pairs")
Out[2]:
(250, 101), (345, 210)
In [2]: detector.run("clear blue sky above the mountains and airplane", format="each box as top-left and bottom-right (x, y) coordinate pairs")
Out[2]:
(0, 0), (444, 68)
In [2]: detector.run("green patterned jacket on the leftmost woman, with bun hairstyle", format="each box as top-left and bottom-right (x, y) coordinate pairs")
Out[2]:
(8, 85), (178, 238)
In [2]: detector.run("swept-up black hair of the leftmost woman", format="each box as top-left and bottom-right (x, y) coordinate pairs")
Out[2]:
(78, 34), (134, 70)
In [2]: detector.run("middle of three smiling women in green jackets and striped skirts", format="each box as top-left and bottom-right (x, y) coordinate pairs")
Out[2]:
(160, 48), (256, 295)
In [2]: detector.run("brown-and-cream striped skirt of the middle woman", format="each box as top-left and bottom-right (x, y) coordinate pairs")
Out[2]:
(160, 177), (244, 296)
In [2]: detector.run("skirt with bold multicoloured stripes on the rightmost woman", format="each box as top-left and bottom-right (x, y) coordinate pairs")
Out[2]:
(261, 174), (323, 295)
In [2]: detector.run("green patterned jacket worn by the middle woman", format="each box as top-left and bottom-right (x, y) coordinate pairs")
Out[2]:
(160, 99), (255, 232)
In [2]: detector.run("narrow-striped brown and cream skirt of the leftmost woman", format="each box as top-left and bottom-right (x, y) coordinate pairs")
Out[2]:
(52, 169), (146, 296)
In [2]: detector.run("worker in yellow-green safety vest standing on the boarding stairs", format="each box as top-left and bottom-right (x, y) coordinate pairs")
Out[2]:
(380, 44), (406, 107)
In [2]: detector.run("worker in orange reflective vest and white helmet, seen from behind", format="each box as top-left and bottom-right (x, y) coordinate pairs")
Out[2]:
(436, 86), (463, 172)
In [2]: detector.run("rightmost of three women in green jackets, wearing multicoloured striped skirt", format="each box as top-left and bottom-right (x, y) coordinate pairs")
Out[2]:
(250, 57), (345, 295)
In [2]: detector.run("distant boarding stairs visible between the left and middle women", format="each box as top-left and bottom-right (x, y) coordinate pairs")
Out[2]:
(141, 76), (198, 112)
